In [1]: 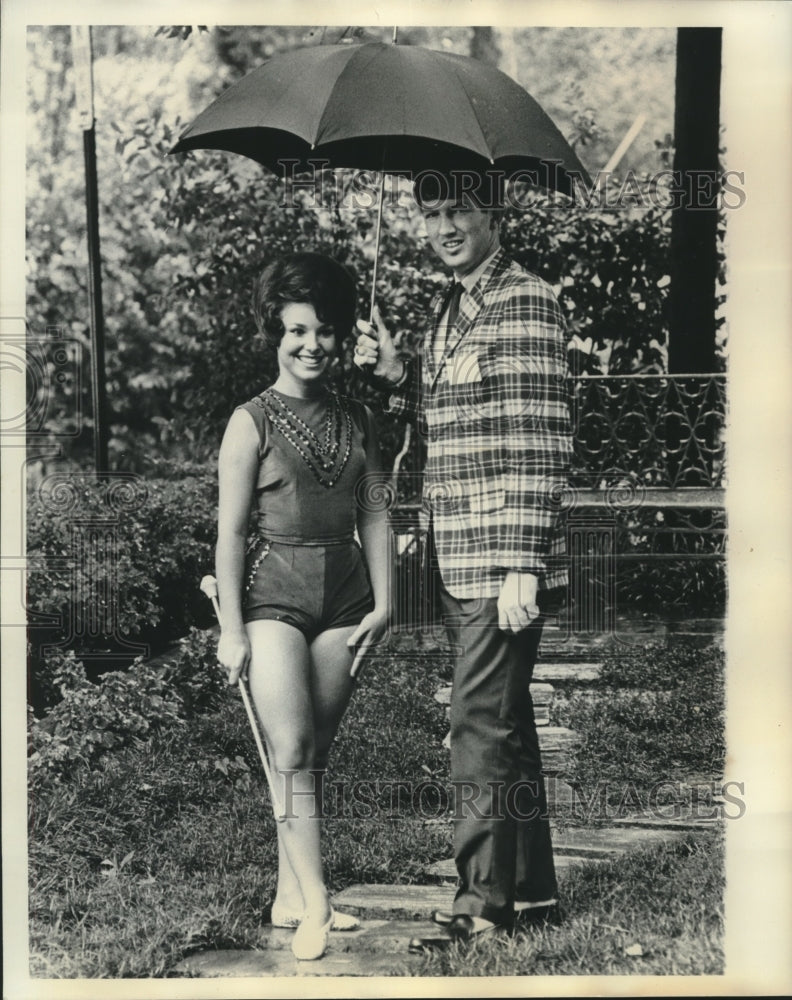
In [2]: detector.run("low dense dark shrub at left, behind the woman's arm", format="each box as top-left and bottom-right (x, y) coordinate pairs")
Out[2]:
(28, 470), (216, 710)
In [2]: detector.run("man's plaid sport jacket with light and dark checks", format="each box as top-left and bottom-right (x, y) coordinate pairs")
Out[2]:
(388, 250), (572, 598)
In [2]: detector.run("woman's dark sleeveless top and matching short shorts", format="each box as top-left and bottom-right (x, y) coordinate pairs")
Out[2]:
(240, 389), (378, 641)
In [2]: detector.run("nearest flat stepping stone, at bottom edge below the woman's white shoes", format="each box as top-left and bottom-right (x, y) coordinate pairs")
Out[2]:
(171, 946), (421, 978)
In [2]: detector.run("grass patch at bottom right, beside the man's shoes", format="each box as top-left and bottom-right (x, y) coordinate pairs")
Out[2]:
(408, 831), (724, 976)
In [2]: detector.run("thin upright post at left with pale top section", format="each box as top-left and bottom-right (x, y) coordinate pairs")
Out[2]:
(71, 25), (109, 475)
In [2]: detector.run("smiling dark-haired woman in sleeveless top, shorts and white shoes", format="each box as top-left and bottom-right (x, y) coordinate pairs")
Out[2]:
(216, 253), (389, 959)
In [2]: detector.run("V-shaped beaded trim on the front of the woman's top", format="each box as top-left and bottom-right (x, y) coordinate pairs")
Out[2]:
(256, 389), (352, 489)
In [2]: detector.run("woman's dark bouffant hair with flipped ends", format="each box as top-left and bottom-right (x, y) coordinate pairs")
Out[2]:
(253, 252), (357, 349)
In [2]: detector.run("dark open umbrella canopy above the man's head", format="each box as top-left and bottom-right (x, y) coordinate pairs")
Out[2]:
(171, 42), (590, 194)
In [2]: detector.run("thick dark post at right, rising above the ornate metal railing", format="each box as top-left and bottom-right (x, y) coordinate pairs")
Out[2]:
(668, 28), (721, 374)
